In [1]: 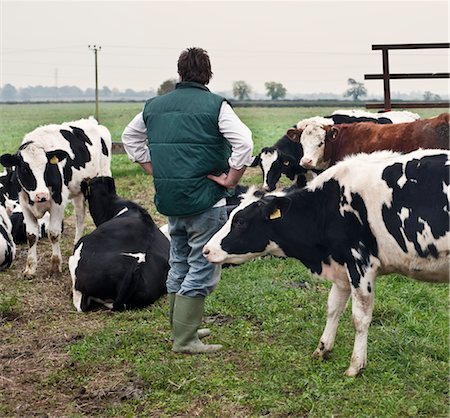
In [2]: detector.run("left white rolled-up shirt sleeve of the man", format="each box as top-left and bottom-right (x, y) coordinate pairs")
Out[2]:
(122, 112), (151, 163)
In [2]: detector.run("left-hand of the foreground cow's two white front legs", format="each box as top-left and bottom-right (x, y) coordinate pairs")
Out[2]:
(313, 282), (351, 359)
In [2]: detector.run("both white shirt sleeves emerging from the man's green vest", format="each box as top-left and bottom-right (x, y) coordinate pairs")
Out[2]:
(122, 101), (253, 170)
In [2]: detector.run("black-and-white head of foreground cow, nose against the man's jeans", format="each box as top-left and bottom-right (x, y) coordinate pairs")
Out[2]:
(203, 189), (291, 264)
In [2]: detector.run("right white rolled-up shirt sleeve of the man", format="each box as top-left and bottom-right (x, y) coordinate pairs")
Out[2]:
(219, 101), (253, 170)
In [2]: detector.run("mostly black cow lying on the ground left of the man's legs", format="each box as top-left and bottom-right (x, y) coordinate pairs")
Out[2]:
(69, 177), (169, 312)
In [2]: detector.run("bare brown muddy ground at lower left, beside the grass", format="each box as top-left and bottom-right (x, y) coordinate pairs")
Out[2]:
(0, 217), (148, 417)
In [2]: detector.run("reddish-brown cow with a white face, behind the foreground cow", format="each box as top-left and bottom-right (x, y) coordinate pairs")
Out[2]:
(286, 113), (449, 170)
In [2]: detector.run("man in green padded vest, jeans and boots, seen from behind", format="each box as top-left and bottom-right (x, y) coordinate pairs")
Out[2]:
(122, 48), (253, 354)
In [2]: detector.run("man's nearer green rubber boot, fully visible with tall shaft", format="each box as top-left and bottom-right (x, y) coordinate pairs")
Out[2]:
(172, 294), (222, 354)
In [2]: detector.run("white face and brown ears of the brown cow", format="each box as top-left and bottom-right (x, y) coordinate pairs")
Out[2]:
(286, 123), (339, 170)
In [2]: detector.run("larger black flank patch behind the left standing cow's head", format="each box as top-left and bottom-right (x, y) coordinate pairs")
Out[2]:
(59, 126), (92, 185)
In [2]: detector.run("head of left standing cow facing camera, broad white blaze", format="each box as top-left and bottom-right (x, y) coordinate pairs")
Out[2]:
(0, 142), (68, 203)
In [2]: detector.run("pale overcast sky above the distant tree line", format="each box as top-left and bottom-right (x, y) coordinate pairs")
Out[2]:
(0, 0), (449, 95)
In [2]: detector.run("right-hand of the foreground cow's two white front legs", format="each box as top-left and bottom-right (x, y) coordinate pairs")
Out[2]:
(345, 269), (376, 377)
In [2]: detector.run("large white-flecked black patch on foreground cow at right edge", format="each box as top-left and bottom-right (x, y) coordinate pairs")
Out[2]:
(382, 154), (449, 258)
